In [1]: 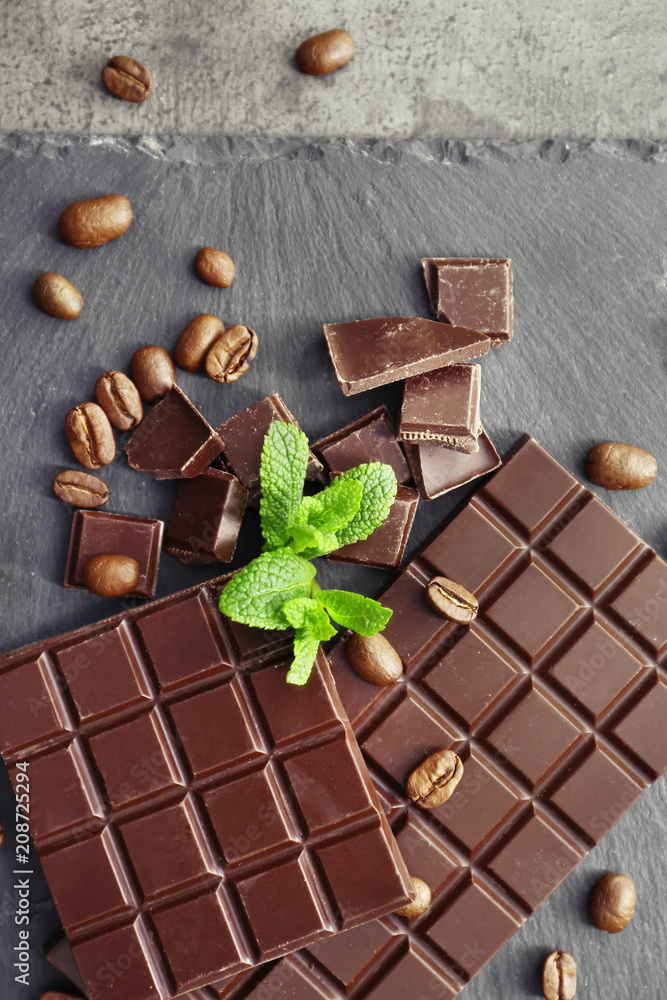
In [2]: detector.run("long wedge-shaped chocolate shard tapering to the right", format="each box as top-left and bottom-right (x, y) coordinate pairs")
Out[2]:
(324, 316), (491, 396)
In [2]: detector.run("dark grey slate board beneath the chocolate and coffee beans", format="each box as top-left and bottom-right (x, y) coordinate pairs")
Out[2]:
(0, 136), (667, 1000)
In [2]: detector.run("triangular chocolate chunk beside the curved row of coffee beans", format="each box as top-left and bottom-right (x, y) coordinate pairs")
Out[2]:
(125, 386), (222, 479)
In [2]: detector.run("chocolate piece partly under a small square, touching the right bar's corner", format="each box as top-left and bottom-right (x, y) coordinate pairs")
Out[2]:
(404, 428), (500, 500)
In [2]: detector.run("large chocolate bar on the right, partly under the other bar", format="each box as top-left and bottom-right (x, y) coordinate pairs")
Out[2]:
(205, 439), (667, 1000)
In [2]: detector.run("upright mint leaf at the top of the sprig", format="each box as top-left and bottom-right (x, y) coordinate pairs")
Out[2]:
(259, 420), (308, 551)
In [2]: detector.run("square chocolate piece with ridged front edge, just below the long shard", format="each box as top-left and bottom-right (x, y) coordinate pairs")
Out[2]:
(398, 365), (482, 453)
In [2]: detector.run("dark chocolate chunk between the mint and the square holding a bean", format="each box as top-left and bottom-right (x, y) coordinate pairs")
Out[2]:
(164, 469), (248, 564)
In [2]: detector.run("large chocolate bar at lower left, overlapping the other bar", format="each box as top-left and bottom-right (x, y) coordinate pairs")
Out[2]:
(0, 585), (409, 1000)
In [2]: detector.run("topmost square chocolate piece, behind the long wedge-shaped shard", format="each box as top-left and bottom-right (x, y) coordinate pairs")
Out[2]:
(422, 257), (514, 347)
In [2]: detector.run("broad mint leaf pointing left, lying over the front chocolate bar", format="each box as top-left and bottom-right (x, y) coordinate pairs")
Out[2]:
(219, 549), (315, 629)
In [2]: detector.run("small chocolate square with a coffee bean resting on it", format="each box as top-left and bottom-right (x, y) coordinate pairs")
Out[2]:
(65, 510), (164, 598)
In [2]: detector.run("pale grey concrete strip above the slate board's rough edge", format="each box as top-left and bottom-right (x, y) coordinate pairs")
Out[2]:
(0, 0), (667, 140)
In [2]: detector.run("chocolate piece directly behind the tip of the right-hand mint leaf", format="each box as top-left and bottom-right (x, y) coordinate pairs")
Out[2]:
(312, 406), (412, 485)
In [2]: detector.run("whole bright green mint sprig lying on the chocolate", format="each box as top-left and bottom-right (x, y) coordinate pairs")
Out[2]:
(220, 420), (397, 684)
